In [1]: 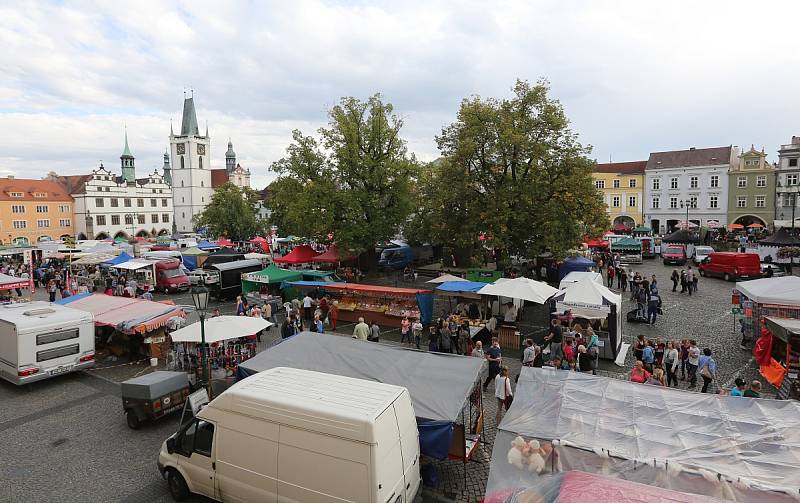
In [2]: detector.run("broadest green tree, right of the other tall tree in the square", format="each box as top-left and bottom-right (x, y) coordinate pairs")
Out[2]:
(414, 81), (608, 264)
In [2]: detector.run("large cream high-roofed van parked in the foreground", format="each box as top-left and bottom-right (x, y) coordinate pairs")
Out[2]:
(158, 367), (420, 503)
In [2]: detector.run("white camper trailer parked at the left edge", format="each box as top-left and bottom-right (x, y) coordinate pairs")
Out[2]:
(0, 302), (94, 384)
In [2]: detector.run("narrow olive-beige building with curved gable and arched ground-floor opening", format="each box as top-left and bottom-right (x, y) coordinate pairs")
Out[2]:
(728, 145), (776, 227)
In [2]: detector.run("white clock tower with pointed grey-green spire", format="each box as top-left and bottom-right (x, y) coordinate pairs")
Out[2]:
(169, 92), (214, 232)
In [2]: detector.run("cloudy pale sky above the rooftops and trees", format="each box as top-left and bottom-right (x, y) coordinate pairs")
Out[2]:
(0, 0), (800, 188)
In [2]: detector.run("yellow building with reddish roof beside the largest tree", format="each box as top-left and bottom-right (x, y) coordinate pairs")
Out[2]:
(592, 161), (647, 228)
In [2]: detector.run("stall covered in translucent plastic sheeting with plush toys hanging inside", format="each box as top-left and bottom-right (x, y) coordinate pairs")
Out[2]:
(486, 367), (800, 503)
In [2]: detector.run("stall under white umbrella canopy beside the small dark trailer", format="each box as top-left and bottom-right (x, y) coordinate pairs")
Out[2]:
(167, 316), (272, 381)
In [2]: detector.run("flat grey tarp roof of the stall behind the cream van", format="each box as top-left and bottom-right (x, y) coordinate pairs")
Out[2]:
(239, 332), (483, 421)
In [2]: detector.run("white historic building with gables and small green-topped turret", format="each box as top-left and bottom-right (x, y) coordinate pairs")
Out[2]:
(56, 133), (173, 239)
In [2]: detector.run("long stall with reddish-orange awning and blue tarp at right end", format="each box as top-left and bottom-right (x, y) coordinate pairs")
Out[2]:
(325, 283), (433, 327)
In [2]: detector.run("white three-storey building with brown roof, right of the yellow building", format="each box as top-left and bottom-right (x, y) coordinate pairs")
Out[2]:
(645, 146), (739, 234)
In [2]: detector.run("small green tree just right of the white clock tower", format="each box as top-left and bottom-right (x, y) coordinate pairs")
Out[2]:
(194, 182), (266, 241)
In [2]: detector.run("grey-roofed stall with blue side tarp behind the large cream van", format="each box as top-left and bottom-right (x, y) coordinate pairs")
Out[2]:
(237, 332), (485, 492)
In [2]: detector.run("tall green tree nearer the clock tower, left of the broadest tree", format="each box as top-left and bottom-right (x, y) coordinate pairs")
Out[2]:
(267, 94), (417, 264)
